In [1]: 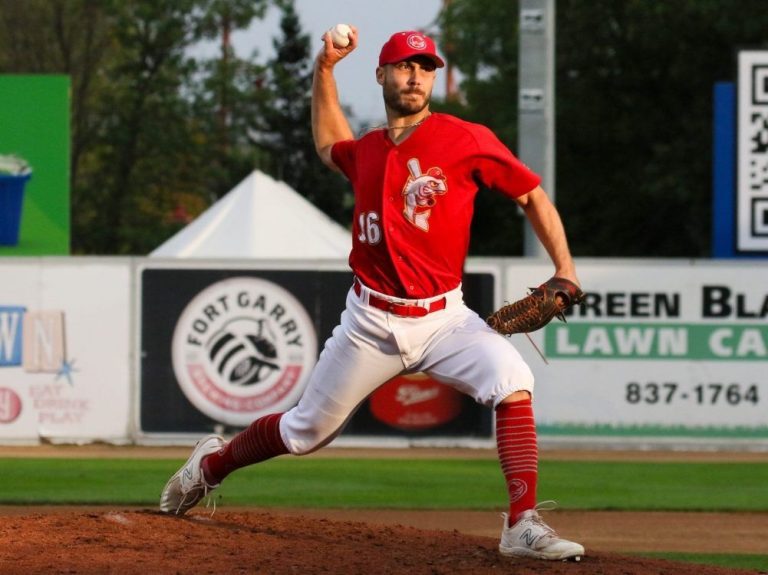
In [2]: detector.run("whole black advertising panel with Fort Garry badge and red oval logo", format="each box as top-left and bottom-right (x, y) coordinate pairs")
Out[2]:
(139, 264), (494, 437)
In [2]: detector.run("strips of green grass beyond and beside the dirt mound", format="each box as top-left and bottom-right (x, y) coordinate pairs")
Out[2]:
(0, 458), (768, 569)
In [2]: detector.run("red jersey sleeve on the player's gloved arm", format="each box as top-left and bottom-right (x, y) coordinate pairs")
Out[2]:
(474, 126), (541, 198)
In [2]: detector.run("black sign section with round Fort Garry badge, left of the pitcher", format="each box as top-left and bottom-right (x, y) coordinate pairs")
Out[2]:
(140, 266), (332, 432)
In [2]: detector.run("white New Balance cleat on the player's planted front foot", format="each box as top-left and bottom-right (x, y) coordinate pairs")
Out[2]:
(499, 509), (584, 561)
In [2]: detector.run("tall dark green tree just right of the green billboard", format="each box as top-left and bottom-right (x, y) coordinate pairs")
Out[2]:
(79, 0), (210, 254)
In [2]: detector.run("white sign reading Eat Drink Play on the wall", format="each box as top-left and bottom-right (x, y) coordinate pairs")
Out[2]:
(0, 258), (131, 443)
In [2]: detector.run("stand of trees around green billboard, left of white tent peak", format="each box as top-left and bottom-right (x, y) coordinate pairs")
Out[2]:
(0, 0), (267, 254)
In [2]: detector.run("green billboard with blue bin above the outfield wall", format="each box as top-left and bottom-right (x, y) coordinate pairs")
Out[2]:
(0, 75), (70, 256)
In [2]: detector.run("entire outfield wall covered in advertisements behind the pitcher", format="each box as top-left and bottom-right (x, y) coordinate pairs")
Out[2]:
(0, 257), (768, 451)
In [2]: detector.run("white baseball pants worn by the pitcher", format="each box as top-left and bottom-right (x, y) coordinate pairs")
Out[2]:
(280, 285), (533, 455)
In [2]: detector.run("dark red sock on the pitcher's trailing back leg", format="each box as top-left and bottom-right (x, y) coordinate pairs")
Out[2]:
(202, 413), (288, 485)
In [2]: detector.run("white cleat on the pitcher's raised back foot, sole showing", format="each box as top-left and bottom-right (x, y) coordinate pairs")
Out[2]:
(160, 435), (224, 515)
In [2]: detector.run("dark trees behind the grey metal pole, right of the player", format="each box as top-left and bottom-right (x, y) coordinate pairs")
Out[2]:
(439, 0), (768, 257)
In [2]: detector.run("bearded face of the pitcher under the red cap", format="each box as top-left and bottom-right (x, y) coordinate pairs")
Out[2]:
(376, 56), (435, 116)
